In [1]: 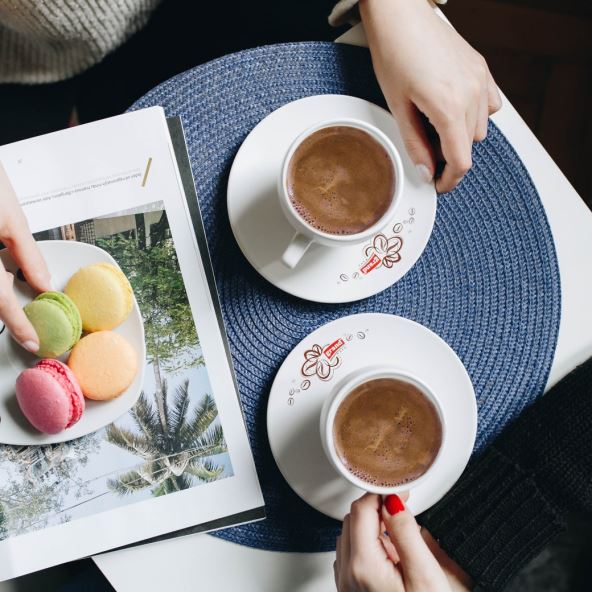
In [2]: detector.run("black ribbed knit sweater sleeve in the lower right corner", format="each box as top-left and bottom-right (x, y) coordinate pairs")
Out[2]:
(420, 358), (592, 592)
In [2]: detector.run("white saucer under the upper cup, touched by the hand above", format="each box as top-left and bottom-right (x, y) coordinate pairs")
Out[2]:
(228, 95), (437, 303)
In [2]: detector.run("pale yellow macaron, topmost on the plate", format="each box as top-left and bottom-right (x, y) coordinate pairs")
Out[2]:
(64, 263), (134, 333)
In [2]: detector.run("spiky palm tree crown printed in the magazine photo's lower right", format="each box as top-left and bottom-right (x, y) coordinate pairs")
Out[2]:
(107, 380), (227, 496)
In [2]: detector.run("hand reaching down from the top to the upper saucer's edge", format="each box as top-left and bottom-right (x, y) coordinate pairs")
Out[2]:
(360, 0), (501, 193)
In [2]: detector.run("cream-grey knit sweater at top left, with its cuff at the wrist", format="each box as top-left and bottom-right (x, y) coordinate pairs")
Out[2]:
(0, 0), (446, 84)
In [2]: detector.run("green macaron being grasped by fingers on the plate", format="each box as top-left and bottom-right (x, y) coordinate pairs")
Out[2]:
(24, 292), (82, 358)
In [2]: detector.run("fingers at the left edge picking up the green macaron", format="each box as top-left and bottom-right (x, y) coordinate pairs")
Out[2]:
(0, 164), (51, 353)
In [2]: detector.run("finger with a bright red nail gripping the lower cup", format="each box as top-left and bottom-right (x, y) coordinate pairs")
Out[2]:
(382, 495), (448, 590)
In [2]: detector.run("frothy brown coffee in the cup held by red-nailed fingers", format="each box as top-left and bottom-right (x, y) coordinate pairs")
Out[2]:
(333, 378), (442, 487)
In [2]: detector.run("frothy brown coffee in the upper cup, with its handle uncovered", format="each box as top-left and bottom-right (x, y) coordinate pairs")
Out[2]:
(286, 125), (396, 235)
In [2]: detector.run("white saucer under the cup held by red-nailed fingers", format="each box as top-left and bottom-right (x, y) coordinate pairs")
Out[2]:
(267, 313), (477, 520)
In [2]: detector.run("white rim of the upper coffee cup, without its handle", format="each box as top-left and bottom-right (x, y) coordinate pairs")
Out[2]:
(279, 117), (405, 245)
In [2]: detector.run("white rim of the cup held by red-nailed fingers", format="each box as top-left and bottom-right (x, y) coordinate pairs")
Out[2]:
(320, 366), (447, 495)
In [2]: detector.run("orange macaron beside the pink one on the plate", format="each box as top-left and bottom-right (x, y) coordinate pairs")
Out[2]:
(68, 331), (138, 401)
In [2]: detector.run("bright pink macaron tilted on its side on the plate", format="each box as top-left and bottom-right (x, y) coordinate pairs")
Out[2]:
(16, 360), (84, 434)
